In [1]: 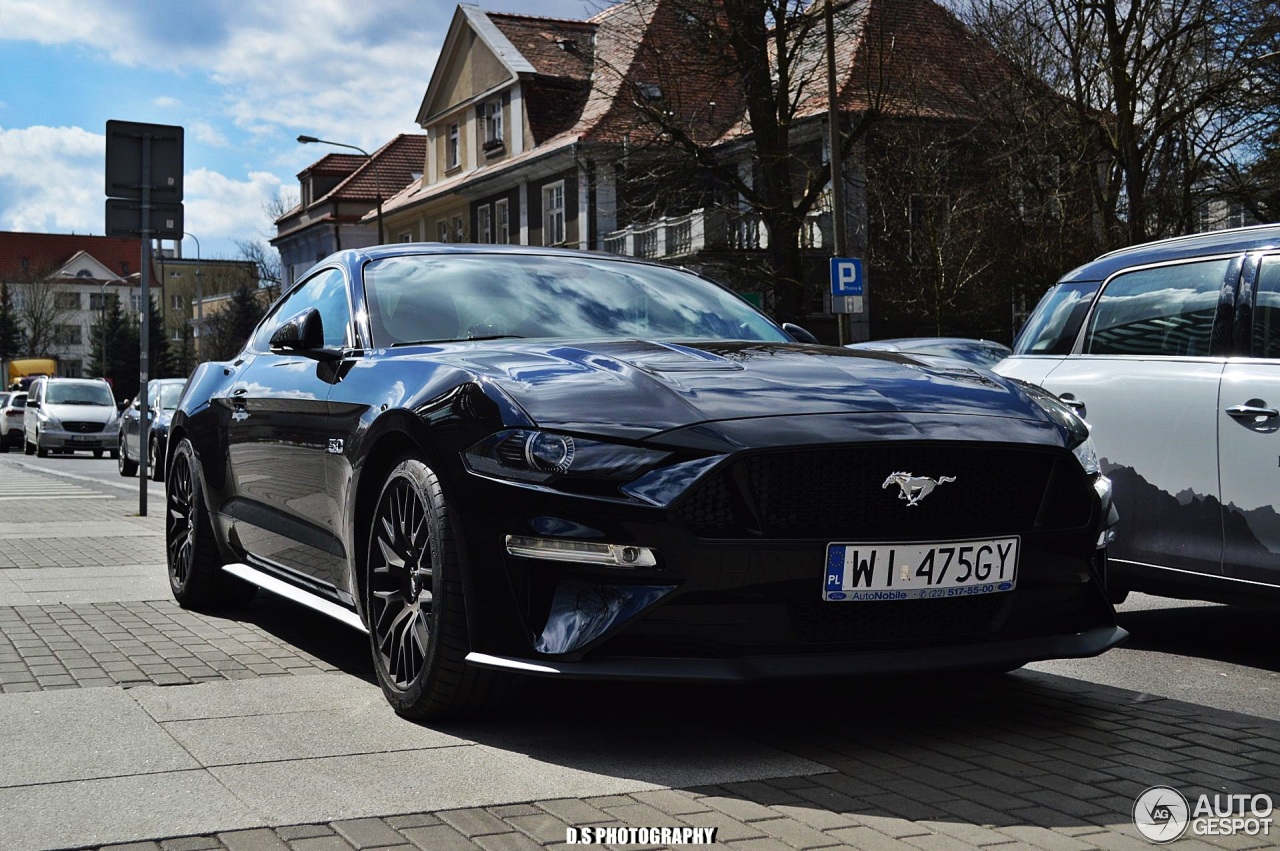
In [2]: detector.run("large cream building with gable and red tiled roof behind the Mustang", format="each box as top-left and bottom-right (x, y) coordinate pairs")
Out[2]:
(364, 0), (1080, 338)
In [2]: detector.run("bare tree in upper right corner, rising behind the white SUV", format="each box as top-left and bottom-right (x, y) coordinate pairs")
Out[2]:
(966, 0), (1276, 244)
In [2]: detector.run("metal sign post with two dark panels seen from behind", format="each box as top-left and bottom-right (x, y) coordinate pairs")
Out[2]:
(102, 120), (183, 517)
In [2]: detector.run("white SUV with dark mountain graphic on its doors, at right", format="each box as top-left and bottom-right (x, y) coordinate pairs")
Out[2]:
(995, 218), (1280, 604)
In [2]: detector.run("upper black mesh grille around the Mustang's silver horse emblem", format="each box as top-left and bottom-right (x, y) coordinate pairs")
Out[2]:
(676, 441), (1092, 540)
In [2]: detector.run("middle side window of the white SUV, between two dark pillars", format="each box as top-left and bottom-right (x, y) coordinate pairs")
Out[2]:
(1084, 260), (1230, 357)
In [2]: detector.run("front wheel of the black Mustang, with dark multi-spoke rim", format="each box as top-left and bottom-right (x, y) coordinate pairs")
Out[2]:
(366, 458), (507, 720)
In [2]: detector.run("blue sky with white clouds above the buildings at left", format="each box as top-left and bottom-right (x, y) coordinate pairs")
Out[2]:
(0, 0), (600, 257)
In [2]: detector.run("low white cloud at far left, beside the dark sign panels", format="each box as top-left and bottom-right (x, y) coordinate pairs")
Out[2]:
(0, 127), (106, 234)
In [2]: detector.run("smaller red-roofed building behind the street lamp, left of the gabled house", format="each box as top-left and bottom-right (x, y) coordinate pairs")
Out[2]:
(271, 134), (426, 284)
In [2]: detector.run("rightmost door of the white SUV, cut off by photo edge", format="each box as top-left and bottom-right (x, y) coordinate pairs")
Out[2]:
(1217, 255), (1280, 585)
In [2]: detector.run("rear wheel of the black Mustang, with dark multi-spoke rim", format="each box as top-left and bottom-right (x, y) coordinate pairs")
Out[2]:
(164, 439), (257, 609)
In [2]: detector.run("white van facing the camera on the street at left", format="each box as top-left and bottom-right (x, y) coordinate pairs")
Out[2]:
(23, 378), (120, 458)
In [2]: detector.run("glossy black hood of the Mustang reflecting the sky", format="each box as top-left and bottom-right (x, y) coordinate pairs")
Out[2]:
(414, 340), (1048, 439)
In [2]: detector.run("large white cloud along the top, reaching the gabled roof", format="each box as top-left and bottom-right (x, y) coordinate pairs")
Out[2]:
(0, 0), (598, 148)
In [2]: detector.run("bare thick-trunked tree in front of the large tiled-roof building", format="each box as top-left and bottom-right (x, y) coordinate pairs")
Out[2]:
(586, 0), (887, 320)
